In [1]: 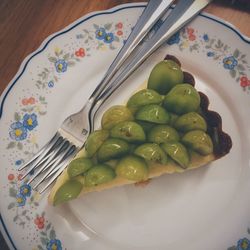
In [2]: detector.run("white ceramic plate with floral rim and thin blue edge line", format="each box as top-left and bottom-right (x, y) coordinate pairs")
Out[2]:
(0, 4), (250, 250)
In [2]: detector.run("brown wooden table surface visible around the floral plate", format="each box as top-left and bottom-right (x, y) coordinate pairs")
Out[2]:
(0, 0), (250, 249)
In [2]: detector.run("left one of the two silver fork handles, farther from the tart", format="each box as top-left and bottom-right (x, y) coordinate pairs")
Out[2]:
(89, 0), (173, 104)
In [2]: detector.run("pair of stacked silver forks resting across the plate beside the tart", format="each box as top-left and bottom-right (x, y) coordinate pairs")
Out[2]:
(19, 0), (211, 193)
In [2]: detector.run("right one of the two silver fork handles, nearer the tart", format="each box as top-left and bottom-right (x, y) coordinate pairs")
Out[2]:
(91, 0), (212, 120)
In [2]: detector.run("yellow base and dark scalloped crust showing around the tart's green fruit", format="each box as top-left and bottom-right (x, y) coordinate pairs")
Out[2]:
(48, 55), (232, 205)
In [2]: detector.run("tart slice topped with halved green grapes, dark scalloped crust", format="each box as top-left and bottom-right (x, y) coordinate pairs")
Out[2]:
(49, 55), (232, 205)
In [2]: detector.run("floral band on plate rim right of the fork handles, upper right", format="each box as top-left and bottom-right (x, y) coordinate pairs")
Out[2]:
(167, 27), (250, 93)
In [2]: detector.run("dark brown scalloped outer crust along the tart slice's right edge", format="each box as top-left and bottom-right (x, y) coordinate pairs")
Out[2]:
(164, 55), (232, 159)
